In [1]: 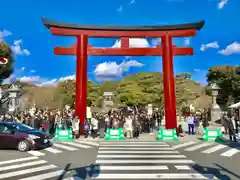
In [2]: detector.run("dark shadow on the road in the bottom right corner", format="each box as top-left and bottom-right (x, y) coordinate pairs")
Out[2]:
(192, 163), (240, 180)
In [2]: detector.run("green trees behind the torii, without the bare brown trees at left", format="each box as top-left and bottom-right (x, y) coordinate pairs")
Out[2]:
(55, 72), (209, 108)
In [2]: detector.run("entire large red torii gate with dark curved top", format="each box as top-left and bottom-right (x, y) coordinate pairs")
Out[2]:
(42, 18), (204, 132)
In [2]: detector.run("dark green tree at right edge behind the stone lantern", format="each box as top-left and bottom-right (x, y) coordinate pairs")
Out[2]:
(207, 66), (240, 104)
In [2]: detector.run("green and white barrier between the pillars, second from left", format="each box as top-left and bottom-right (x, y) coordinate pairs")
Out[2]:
(104, 128), (126, 141)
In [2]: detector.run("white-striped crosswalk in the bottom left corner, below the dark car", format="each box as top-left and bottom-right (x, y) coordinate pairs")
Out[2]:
(0, 156), (64, 180)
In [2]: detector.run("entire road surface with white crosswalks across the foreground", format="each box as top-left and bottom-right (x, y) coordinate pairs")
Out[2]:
(0, 140), (240, 180)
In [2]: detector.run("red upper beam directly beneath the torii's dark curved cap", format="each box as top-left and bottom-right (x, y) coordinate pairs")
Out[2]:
(50, 27), (197, 38)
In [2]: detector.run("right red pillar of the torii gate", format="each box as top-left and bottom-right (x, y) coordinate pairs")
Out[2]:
(162, 36), (177, 129)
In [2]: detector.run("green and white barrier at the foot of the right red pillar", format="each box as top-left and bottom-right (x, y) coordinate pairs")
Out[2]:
(156, 128), (179, 141)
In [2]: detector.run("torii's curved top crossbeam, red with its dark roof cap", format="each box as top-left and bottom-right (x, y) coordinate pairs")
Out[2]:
(42, 18), (205, 38)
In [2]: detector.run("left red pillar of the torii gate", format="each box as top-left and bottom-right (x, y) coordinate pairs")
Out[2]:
(73, 35), (88, 134)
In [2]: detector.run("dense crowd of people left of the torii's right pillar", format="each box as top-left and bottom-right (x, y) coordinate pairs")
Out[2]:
(0, 107), (163, 138)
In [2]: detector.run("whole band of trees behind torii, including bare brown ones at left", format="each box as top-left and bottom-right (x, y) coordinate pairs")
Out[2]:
(15, 72), (210, 109)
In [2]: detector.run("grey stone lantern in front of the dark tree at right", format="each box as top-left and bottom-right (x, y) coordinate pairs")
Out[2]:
(211, 83), (221, 124)
